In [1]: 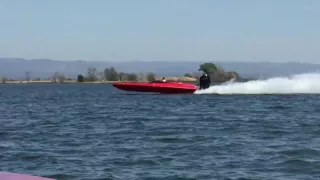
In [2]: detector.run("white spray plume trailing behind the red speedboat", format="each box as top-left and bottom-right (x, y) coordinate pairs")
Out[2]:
(195, 73), (320, 94)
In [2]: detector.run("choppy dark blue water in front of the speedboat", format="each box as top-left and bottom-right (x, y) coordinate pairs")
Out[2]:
(0, 84), (320, 180)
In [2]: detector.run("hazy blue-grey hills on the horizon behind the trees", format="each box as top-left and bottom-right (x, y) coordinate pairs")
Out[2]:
(0, 58), (320, 78)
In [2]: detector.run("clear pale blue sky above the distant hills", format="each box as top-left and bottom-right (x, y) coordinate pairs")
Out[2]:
(0, 0), (320, 62)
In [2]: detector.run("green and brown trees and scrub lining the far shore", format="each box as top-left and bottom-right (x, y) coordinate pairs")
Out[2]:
(1, 63), (240, 83)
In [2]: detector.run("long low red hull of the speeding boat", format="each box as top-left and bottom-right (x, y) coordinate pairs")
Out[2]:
(113, 82), (197, 94)
